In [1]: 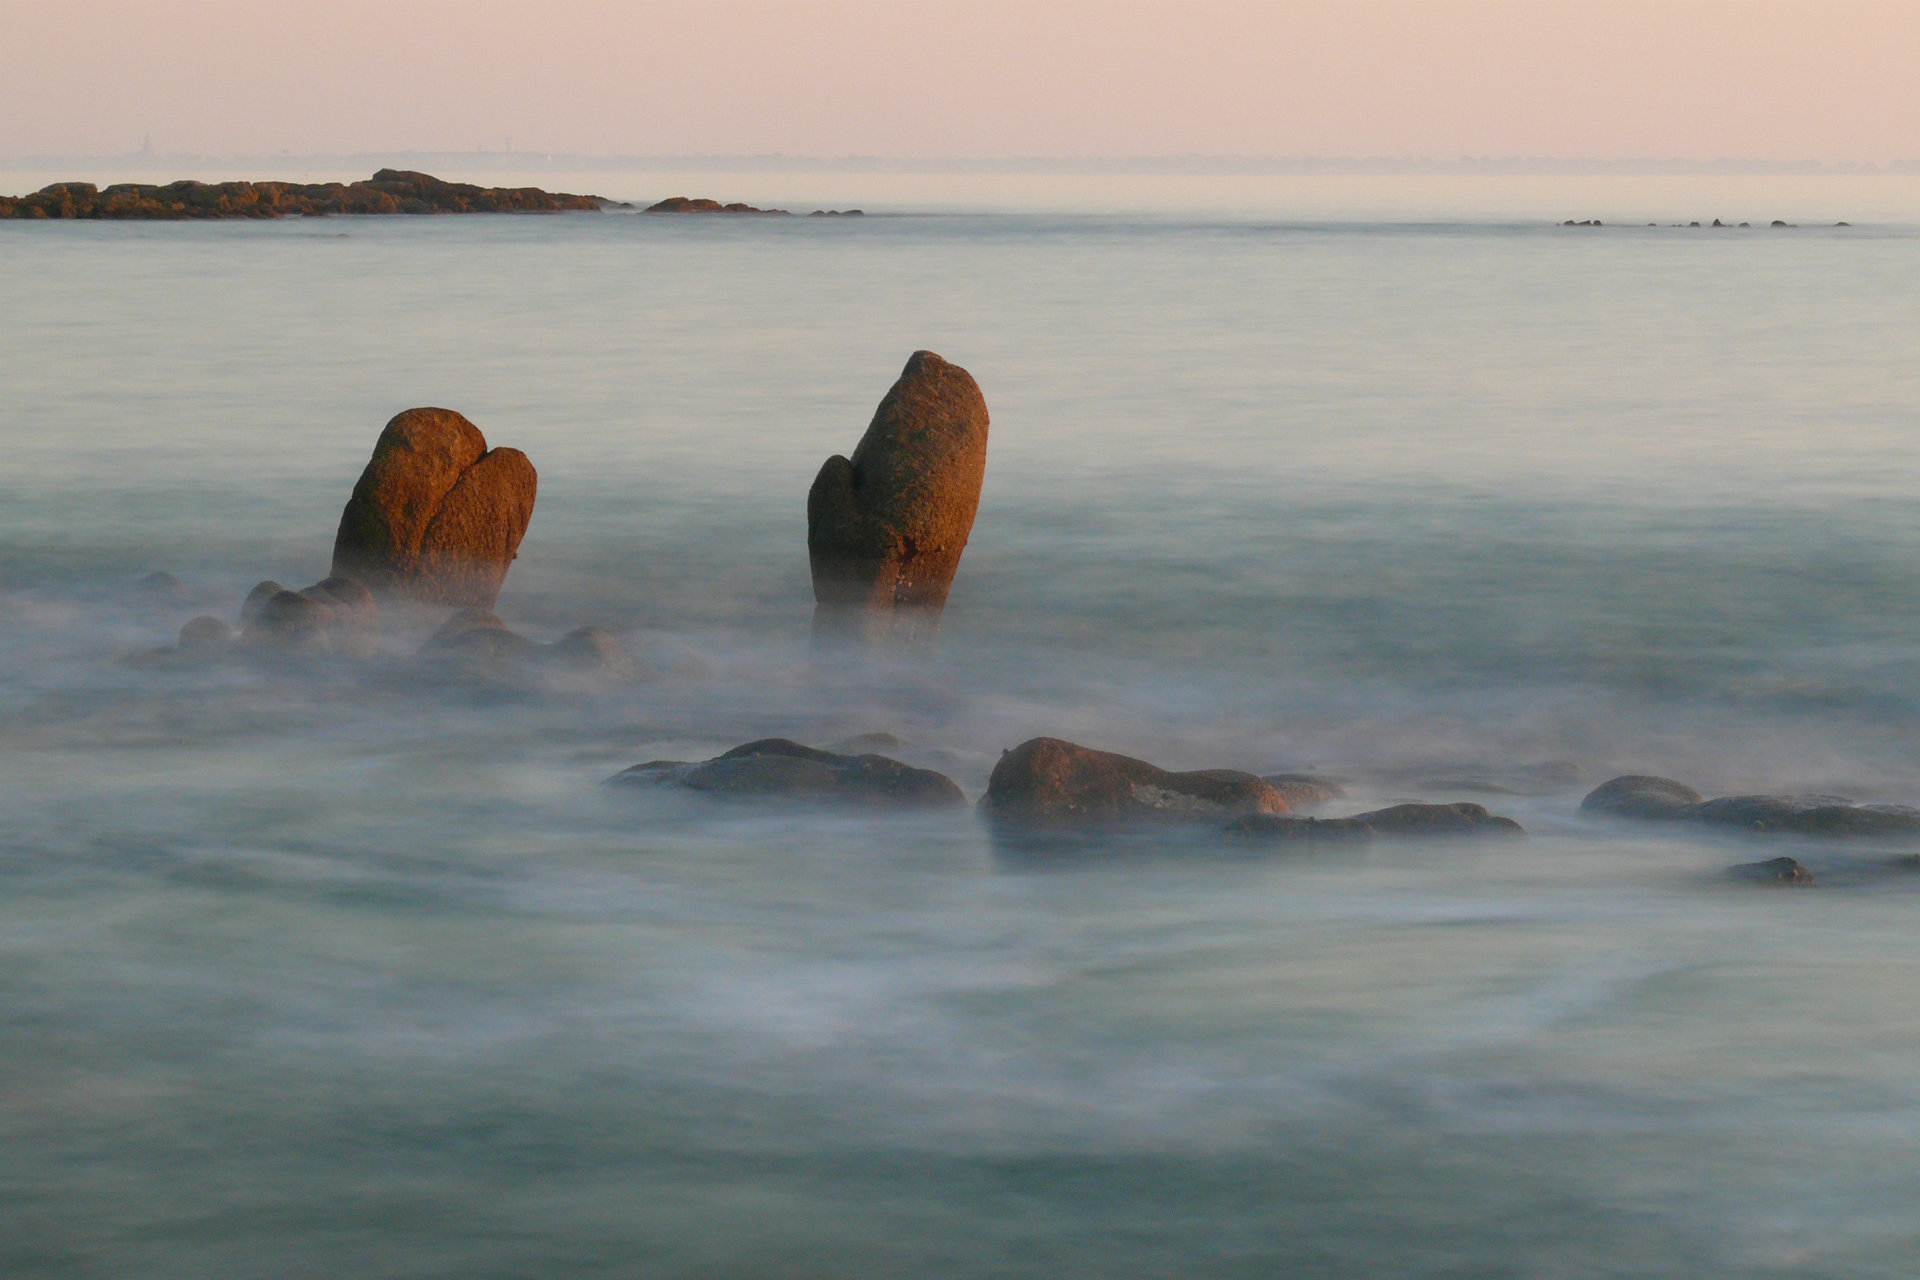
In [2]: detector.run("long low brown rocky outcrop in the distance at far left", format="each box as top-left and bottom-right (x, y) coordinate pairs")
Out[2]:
(0, 169), (628, 221)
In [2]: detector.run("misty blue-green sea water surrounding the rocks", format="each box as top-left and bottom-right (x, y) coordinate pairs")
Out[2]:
(0, 175), (1920, 1278)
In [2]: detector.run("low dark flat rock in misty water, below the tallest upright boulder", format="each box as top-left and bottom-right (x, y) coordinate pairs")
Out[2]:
(609, 737), (966, 810)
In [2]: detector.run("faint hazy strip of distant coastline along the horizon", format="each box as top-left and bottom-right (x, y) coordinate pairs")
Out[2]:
(0, 150), (1920, 177)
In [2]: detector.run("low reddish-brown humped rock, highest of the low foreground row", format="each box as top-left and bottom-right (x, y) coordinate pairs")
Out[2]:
(979, 737), (1288, 833)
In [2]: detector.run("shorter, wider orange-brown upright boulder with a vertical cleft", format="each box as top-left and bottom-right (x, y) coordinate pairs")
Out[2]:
(332, 409), (538, 608)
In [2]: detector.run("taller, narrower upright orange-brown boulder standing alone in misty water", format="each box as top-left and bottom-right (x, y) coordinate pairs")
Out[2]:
(806, 351), (987, 641)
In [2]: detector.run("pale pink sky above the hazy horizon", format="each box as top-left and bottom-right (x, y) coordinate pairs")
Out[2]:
(0, 0), (1920, 163)
